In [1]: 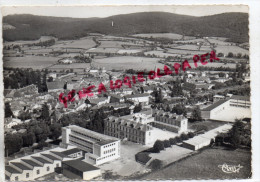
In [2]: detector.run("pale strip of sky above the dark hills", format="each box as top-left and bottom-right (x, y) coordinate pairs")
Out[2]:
(2, 5), (248, 18)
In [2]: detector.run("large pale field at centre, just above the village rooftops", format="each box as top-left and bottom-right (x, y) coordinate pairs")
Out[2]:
(92, 56), (163, 70)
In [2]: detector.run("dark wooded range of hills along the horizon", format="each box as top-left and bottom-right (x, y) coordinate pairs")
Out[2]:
(3, 12), (249, 43)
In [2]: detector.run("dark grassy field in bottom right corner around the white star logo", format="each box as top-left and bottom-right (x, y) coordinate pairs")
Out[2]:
(141, 148), (251, 180)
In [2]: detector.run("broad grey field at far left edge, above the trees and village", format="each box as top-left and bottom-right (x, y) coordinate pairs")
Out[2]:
(4, 56), (60, 69)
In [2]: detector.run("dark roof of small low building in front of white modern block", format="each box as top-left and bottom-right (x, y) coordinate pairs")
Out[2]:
(62, 159), (99, 172)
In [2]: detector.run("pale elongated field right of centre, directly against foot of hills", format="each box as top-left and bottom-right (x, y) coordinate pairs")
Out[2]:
(133, 33), (195, 40)
